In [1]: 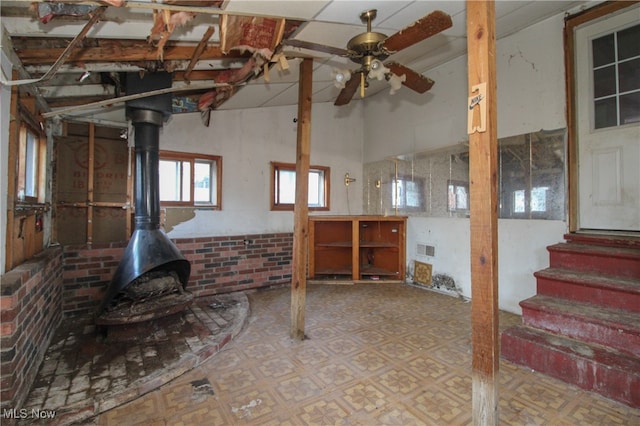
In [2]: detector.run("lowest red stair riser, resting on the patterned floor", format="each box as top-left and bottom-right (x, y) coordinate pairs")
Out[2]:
(502, 334), (640, 408)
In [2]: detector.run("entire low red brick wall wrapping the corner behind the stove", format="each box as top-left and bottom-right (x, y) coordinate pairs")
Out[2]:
(0, 233), (293, 409)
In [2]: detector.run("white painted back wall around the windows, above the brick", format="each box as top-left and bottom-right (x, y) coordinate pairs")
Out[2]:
(160, 103), (363, 238)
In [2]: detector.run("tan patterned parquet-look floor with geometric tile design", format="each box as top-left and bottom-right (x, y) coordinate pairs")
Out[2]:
(93, 284), (640, 426)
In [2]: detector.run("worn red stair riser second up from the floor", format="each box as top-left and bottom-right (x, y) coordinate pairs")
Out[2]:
(522, 306), (640, 357)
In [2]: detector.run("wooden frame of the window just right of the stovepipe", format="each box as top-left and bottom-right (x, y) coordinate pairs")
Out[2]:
(159, 150), (222, 210)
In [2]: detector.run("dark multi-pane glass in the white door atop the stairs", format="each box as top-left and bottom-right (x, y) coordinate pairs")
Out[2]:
(591, 24), (640, 129)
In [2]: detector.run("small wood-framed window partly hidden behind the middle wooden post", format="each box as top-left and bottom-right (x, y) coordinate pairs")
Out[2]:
(271, 162), (330, 210)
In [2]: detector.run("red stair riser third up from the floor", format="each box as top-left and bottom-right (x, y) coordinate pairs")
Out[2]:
(537, 277), (640, 312)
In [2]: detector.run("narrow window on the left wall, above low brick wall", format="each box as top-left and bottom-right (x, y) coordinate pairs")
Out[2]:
(17, 125), (46, 203)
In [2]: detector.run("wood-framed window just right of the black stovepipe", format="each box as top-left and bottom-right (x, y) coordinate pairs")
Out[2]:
(160, 151), (222, 209)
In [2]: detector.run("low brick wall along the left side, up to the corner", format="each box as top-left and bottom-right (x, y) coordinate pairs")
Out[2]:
(0, 247), (62, 409)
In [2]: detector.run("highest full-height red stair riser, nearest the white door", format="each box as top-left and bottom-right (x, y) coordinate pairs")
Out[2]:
(549, 250), (640, 280)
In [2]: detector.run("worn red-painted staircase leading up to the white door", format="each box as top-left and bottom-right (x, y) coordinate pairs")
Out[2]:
(501, 234), (640, 408)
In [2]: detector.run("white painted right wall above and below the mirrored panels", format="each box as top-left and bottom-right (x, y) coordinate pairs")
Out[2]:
(364, 15), (567, 313)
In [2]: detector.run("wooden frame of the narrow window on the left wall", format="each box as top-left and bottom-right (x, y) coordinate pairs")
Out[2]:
(15, 122), (47, 204)
